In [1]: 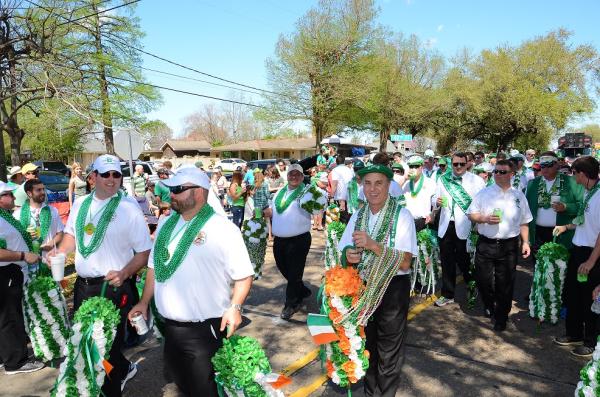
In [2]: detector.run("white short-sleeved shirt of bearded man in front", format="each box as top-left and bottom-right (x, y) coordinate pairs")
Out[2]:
(148, 214), (254, 320)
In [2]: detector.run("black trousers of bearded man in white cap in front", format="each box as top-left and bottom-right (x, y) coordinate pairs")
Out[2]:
(165, 318), (226, 397)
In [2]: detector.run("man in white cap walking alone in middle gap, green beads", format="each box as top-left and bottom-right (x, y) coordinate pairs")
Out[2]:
(264, 164), (312, 320)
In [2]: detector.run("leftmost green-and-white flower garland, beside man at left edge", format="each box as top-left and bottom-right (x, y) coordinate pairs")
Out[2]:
(23, 276), (69, 361)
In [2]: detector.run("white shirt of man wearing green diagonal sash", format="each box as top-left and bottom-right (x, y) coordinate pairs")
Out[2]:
(431, 172), (485, 240)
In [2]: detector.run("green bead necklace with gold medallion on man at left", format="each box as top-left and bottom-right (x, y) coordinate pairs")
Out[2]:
(75, 191), (123, 258)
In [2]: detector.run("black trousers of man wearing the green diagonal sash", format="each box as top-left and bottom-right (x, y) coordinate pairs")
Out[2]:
(440, 221), (473, 299)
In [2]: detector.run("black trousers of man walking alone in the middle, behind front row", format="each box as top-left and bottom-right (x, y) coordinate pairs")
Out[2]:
(273, 233), (311, 307)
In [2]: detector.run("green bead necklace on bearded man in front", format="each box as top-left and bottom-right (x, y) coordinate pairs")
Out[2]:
(154, 204), (215, 283)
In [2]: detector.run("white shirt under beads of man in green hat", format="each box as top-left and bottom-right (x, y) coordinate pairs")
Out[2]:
(338, 203), (418, 275)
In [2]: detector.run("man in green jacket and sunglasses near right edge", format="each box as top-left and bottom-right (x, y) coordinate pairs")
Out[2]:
(526, 151), (584, 255)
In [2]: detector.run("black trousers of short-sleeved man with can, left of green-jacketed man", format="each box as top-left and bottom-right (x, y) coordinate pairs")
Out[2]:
(475, 235), (519, 324)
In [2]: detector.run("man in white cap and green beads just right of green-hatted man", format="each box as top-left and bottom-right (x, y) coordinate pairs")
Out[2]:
(402, 155), (436, 233)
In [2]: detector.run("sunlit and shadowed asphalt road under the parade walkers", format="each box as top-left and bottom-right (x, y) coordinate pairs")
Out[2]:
(0, 233), (586, 397)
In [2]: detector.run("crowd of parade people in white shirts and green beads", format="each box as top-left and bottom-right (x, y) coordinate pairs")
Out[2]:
(0, 146), (600, 396)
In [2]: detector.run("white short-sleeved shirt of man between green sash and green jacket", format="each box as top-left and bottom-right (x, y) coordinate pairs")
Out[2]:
(467, 184), (533, 239)
